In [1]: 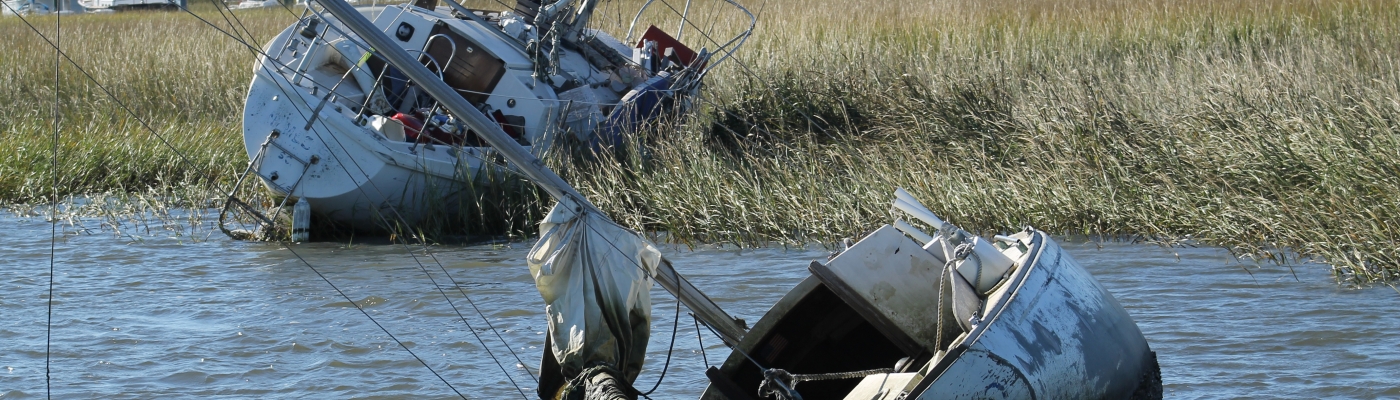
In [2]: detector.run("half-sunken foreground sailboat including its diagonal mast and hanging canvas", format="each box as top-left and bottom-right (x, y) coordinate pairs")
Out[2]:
(301, 0), (1162, 399)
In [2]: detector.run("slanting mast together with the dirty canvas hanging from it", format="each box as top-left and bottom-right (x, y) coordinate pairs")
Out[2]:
(302, 0), (753, 399)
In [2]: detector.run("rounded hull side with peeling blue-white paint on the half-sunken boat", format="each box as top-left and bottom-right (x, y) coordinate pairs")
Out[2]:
(910, 232), (1161, 399)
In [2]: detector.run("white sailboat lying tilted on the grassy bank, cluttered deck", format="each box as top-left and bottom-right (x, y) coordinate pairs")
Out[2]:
(225, 0), (748, 229)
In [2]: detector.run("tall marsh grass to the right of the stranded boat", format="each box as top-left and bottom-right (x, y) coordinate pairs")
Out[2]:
(571, 1), (1400, 283)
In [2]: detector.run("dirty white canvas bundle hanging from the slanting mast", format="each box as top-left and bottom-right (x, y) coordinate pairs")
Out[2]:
(528, 203), (661, 382)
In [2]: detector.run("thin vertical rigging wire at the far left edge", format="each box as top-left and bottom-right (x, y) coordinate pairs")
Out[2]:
(45, 1), (63, 399)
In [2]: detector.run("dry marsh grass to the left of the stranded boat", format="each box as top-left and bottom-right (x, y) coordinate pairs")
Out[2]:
(0, 6), (293, 201)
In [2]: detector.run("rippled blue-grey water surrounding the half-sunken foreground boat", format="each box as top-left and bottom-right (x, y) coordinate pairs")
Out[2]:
(0, 213), (1400, 399)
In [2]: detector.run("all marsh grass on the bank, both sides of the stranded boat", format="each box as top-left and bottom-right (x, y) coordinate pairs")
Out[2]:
(0, 0), (1400, 283)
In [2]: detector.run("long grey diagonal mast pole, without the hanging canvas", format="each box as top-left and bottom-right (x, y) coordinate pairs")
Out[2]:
(318, 0), (746, 345)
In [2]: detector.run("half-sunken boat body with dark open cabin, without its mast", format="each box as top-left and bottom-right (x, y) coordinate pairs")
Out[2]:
(701, 190), (1162, 400)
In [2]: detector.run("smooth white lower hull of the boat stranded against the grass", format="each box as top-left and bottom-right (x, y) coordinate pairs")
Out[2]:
(244, 49), (487, 231)
